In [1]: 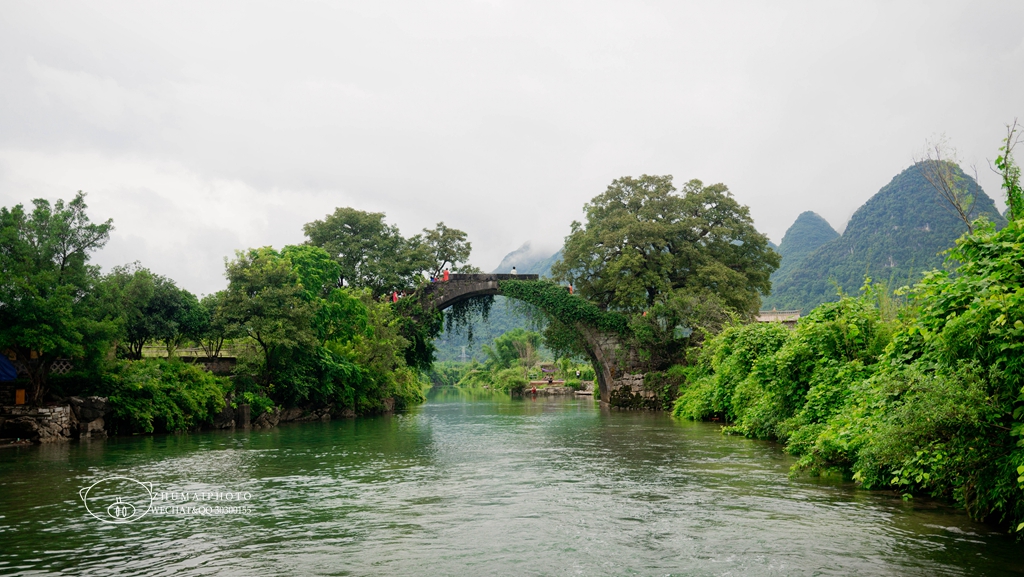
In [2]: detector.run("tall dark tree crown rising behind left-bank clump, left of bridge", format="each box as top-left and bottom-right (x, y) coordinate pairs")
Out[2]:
(302, 207), (426, 296)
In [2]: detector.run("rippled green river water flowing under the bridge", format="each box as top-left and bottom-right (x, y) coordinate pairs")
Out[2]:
(0, 389), (1024, 576)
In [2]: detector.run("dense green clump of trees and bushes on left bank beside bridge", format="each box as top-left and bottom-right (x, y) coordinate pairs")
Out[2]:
(223, 246), (422, 414)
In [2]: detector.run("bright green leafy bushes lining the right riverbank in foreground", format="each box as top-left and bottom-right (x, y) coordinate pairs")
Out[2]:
(674, 220), (1024, 529)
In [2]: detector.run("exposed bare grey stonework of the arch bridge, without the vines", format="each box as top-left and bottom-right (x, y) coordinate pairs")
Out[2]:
(411, 274), (653, 404)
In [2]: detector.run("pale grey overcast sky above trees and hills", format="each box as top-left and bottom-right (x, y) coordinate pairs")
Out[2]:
(0, 0), (1024, 293)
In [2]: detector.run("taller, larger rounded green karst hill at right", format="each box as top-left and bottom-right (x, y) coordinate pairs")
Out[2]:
(762, 165), (1006, 312)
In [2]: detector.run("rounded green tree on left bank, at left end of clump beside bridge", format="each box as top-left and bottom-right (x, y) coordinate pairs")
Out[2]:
(222, 247), (316, 385)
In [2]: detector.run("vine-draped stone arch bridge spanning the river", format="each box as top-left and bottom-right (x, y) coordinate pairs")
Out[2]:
(418, 274), (638, 403)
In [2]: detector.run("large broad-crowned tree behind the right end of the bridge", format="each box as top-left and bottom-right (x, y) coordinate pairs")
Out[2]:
(552, 175), (779, 317)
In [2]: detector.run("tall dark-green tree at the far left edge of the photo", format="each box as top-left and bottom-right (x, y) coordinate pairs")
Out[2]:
(0, 191), (114, 403)
